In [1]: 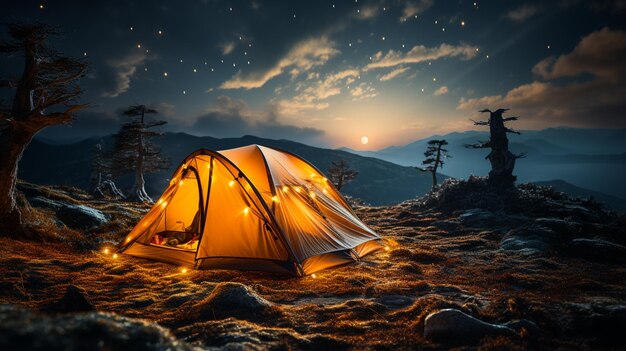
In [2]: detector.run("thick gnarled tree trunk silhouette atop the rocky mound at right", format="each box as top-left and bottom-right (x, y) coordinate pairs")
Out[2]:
(465, 108), (525, 184)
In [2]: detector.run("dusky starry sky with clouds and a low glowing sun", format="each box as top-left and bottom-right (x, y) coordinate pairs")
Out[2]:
(0, 0), (626, 150)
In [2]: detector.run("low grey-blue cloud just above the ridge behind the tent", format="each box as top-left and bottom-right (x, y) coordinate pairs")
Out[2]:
(191, 95), (324, 141)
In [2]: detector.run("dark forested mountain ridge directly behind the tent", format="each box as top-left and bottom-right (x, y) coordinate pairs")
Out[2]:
(19, 133), (444, 205)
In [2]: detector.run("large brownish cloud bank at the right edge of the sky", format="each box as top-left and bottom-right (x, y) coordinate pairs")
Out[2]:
(457, 28), (626, 128)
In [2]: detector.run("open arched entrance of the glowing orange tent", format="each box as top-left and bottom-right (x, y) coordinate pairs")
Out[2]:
(150, 166), (205, 252)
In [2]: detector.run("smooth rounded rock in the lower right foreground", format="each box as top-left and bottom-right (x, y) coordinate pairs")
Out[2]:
(424, 308), (515, 340)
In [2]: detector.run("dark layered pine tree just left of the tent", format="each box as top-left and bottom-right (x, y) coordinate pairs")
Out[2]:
(111, 105), (169, 202)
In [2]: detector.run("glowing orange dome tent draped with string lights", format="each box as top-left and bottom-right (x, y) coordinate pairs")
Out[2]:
(121, 145), (381, 275)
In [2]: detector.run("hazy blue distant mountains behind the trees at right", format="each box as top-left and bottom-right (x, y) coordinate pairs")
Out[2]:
(343, 128), (626, 199)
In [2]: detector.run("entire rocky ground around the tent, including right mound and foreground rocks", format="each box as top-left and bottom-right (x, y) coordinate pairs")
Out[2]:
(0, 178), (626, 350)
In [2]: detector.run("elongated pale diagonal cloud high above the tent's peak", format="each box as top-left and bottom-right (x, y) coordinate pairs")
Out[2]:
(220, 36), (339, 89)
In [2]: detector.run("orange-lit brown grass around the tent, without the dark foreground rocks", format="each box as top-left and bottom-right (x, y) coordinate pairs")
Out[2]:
(0, 183), (626, 350)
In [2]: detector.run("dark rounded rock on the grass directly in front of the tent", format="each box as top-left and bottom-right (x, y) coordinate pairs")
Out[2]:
(190, 282), (277, 319)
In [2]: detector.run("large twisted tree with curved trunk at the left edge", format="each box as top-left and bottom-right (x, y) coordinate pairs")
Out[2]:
(0, 23), (87, 235)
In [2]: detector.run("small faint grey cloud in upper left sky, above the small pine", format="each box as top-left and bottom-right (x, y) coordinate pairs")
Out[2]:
(101, 53), (146, 97)
